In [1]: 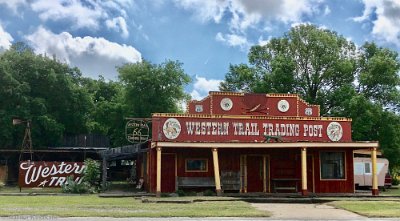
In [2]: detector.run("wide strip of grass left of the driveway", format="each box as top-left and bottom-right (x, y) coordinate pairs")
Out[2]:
(0, 195), (270, 217)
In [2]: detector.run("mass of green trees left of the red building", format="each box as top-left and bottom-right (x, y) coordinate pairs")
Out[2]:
(0, 43), (190, 148)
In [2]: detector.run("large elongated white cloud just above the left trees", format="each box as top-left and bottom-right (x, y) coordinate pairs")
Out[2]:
(25, 27), (141, 79)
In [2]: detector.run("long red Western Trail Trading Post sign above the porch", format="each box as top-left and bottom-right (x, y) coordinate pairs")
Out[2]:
(153, 118), (351, 142)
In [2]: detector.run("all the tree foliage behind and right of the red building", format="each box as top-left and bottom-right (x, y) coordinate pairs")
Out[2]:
(220, 25), (400, 165)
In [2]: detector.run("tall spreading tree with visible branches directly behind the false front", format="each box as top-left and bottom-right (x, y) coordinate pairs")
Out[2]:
(220, 25), (356, 113)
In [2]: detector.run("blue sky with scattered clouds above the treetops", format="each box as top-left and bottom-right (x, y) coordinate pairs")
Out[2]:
(0, 0), (400, 99)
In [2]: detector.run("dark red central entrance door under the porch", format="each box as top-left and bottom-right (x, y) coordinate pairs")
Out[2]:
(246, 155), (268, 192)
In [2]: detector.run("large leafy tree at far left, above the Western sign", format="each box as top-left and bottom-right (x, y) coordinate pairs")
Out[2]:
(0, 43), (92, 147)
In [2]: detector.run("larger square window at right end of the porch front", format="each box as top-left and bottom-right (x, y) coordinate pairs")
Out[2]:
(320, 152), (345, 179)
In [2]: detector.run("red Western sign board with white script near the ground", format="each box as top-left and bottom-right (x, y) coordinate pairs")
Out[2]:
(19, 161), (85, 187)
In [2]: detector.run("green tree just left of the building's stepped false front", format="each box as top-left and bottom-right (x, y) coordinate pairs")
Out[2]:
(118, 61), (191, 117)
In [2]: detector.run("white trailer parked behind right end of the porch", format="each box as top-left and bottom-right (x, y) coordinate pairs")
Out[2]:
(354, 157), (391, 188)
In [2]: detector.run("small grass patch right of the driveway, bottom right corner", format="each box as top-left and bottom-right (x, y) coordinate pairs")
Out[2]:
(331, 201), (400, 217)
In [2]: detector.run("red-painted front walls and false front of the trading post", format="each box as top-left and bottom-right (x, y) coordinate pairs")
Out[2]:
(148, 92), (372, 195)
